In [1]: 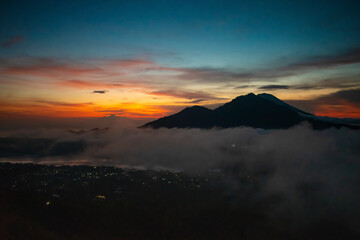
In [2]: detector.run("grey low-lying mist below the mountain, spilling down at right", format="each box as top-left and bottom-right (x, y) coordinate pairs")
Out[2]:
(3, 119), (360, 235)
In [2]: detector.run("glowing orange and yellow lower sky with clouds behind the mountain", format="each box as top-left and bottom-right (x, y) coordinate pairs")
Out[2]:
(0, 57), (360, 118)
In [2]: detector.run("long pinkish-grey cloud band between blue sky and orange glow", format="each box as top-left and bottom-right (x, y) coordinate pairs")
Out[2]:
(0, 48), (360, 87)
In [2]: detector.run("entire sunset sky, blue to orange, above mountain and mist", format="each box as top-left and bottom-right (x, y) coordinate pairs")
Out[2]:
(0, 0), (360, 119)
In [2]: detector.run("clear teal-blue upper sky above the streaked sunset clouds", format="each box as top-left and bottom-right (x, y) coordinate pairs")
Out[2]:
(0, 1), (360, 65)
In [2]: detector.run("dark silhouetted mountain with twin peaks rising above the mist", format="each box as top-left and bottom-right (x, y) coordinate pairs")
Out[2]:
(141, 93), (358, 129)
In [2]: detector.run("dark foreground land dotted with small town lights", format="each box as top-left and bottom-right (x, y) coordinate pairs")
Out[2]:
(0, 163), (360, 239)
